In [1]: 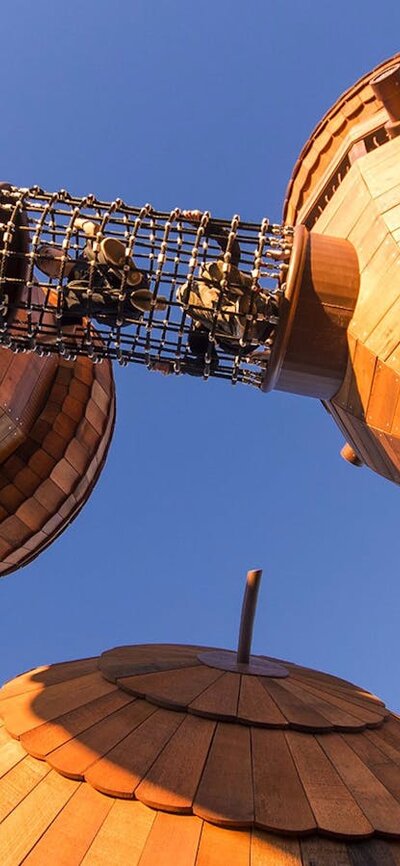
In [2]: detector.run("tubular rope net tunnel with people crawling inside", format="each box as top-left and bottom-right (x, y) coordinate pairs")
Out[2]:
(0, 184), (293, 386)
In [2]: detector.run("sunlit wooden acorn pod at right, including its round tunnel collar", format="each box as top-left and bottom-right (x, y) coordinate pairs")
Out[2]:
(276, 55), (400, 483)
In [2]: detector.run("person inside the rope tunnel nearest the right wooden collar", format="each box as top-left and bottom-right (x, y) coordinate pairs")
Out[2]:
(177, 210), (278, 367)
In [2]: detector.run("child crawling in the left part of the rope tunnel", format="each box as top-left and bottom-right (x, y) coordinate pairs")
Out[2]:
(35, 219), (167, 331)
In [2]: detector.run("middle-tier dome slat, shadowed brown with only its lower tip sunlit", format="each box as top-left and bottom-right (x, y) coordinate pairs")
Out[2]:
(85, 710), (183, 797)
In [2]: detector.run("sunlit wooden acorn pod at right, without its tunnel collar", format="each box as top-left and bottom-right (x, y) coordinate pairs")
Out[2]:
(278, 55), (400, 484)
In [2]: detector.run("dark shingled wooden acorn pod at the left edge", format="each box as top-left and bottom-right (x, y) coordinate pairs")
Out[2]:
(0, 184), (115, 575)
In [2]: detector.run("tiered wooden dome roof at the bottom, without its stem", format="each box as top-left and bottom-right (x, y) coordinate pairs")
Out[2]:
(0, 645), (400, 866)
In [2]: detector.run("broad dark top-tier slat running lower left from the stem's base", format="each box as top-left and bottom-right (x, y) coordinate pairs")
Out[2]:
(118, 665), (223, 708)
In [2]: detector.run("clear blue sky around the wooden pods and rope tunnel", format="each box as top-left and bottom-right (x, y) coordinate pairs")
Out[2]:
(0, 0), (400, 711)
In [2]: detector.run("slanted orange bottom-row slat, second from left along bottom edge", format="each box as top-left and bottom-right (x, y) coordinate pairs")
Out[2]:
(24, 785), (113, 866)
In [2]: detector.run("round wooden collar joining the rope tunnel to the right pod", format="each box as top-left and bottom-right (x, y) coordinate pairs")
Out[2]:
(264, 225), (360, 399)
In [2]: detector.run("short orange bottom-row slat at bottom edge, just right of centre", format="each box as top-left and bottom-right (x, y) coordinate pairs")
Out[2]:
(196, 823), (248, 866)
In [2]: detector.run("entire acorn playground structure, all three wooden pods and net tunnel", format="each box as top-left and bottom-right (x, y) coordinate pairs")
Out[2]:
(0, 52), (400, 866)
